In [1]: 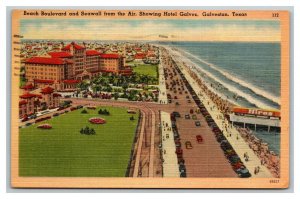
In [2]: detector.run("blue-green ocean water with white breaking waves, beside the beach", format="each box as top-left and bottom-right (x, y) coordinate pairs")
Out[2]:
(163, 42), (281, 154)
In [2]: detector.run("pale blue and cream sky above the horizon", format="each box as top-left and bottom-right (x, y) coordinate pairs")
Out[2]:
(20, 19), (281, 42)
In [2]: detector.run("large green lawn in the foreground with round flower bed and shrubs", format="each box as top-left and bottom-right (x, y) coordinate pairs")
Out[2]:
(19, 107), (138, 177)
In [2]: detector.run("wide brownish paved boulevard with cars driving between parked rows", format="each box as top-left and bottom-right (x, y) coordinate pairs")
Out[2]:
(161, 49), (237, 177)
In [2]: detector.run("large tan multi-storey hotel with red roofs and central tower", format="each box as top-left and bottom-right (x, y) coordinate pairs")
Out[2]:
(25, 42), (132, 90)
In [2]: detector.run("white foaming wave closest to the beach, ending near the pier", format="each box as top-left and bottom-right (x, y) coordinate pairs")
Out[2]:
(166, 47), (274, 109)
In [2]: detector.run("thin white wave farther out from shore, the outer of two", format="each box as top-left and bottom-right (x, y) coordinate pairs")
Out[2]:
(179, 49), (280, 105)
